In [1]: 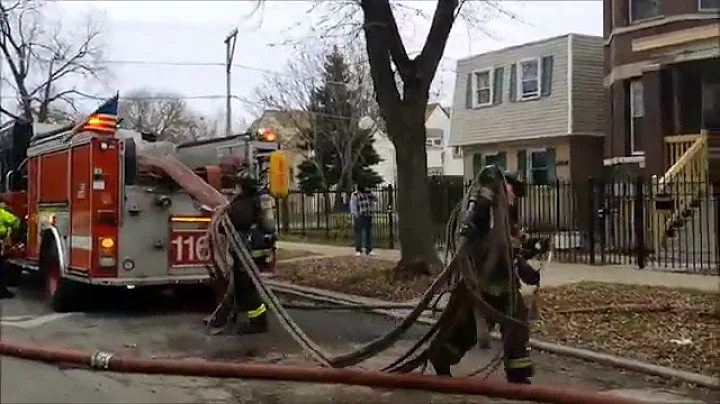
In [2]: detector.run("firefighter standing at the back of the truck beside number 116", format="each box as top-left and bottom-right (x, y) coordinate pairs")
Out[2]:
(228, 169), (274, 334)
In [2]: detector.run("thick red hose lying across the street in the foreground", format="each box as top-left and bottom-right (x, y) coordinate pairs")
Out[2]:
(0, 341), (641, 404)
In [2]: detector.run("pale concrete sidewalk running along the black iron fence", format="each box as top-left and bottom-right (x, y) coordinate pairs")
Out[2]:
(278, 241), (720, 293)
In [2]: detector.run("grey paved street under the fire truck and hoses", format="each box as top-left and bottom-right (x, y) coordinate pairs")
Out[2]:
(0, 280), (703, 404)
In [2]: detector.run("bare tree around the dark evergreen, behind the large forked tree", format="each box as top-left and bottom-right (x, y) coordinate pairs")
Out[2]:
(246, 44), (383, 191)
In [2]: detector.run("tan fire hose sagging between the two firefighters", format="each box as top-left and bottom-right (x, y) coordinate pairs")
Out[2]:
(209, 167), (548, 374)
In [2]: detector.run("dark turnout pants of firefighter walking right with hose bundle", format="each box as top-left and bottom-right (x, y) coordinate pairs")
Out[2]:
(431, 289), (534, 383)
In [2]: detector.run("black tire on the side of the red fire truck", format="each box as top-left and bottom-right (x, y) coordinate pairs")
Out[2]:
(39, 232), (83, 313)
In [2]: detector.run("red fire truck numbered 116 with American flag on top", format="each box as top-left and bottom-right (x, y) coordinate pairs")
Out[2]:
(0, 96), (286, 311)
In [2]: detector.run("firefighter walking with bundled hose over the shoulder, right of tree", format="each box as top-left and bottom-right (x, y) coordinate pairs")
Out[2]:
(430, 167), (539, 384)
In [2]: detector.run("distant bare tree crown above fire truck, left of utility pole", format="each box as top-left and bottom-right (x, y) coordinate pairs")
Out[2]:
(118, 89), (217, 143)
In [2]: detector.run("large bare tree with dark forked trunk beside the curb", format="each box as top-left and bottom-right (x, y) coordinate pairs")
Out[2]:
(250, 0), (516, 273)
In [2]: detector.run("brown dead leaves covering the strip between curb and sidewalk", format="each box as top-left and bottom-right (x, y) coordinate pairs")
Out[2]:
(277, 257), (720, 375)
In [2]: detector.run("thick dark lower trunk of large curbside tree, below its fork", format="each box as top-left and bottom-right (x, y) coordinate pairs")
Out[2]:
(388, 113), (442, 275)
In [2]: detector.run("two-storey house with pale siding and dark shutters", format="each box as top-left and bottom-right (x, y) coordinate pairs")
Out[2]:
(448, 34), (606, 230)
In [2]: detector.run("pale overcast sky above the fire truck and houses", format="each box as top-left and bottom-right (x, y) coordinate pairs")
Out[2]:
(4, 0), (602, 129)
